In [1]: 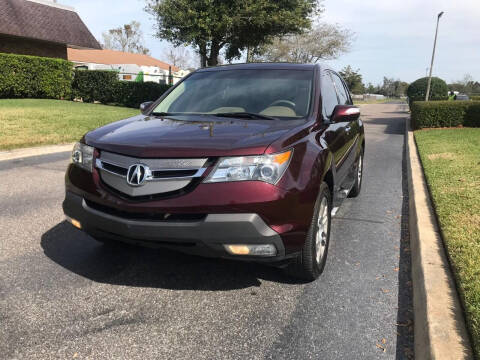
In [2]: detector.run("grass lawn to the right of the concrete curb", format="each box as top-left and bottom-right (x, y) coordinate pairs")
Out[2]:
(415, 128), (480, 358)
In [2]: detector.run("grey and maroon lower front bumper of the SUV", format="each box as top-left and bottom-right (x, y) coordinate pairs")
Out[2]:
(63, 191), (295, 262)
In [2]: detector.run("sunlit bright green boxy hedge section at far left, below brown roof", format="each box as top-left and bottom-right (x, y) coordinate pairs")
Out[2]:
(0, 53), (72, 99)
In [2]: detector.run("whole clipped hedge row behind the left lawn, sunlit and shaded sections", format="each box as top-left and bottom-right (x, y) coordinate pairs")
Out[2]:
(0, 53), (170, 108)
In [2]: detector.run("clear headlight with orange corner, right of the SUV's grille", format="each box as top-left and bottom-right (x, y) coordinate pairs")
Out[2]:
(205, 150), (293, 184)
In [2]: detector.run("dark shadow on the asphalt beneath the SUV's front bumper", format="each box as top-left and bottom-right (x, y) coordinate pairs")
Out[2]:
(41, 221), (297, 291)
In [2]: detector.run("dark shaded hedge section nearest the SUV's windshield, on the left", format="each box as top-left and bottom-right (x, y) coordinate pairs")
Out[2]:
(114, 81), (170, 108)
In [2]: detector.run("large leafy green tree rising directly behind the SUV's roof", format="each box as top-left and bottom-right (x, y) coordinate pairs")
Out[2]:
(146, 0), (322, 67)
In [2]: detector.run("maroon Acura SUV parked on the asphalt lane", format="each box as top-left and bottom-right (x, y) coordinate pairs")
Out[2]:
(63, 64), (365, 280)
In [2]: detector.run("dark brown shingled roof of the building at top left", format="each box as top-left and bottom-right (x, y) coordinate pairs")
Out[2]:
(0, 0), (101, 49)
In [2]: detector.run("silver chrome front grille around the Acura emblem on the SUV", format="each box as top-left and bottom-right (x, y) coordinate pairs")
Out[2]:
(95, 151), (208, 197)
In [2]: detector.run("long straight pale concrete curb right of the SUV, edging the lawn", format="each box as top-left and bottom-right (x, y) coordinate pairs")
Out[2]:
(405, 119), (473, 360)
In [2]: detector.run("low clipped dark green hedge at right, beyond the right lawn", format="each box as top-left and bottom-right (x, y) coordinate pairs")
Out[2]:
(411, 101), (480, 129)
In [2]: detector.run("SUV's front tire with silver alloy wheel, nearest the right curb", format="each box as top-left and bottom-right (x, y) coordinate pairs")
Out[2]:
(285, 183), (332, 281)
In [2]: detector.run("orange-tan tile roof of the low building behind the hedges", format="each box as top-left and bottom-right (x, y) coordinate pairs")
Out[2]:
(67, 48), (179, 71)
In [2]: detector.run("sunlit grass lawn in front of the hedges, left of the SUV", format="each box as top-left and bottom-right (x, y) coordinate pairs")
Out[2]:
(0, 99), (139, 150)
